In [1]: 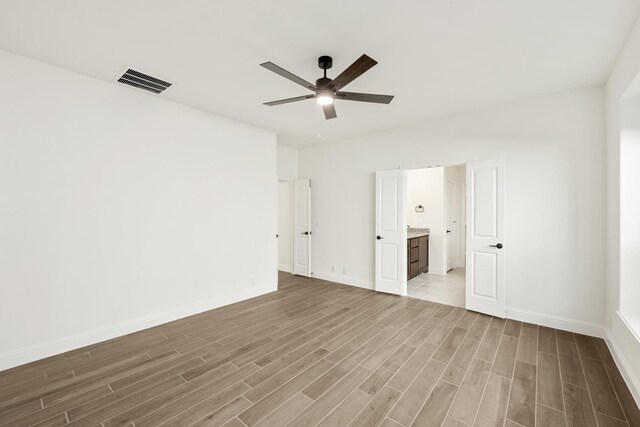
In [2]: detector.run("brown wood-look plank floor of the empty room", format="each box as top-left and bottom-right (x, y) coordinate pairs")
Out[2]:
(0, 274), (640, 427)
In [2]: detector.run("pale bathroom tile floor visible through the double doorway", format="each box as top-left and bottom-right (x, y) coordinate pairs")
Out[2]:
(407, 268), (465, 308)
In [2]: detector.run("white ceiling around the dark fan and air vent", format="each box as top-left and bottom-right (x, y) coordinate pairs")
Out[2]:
(0, 0), (640, 146)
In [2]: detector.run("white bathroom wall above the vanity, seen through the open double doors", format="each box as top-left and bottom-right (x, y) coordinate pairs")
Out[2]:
(407, 168), (446, 274)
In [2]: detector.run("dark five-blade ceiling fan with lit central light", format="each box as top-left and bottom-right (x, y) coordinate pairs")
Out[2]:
(260, 55), (393, 120)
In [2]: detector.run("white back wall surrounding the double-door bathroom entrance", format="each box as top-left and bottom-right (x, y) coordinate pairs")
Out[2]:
(299, 87), (605, 334)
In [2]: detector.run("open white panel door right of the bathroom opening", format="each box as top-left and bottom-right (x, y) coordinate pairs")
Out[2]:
(466, 159), (506, 317)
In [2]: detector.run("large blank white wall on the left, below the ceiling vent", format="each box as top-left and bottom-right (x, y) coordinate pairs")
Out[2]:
(0, 52), (277, 369)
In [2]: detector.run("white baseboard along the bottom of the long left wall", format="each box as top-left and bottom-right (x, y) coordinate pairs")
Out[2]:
(0, 284), (278, 371)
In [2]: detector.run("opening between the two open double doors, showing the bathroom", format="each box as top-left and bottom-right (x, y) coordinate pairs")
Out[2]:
(406, 164), (466, 307)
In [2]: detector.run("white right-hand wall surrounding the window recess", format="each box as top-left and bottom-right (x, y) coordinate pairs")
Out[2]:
(606, 15), (640, 402)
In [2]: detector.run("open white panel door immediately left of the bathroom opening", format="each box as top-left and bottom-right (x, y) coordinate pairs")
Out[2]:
(375, 170), (407, 295)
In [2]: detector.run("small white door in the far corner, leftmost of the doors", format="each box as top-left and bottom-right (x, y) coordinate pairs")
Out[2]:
(293, 179), (311, 277)
